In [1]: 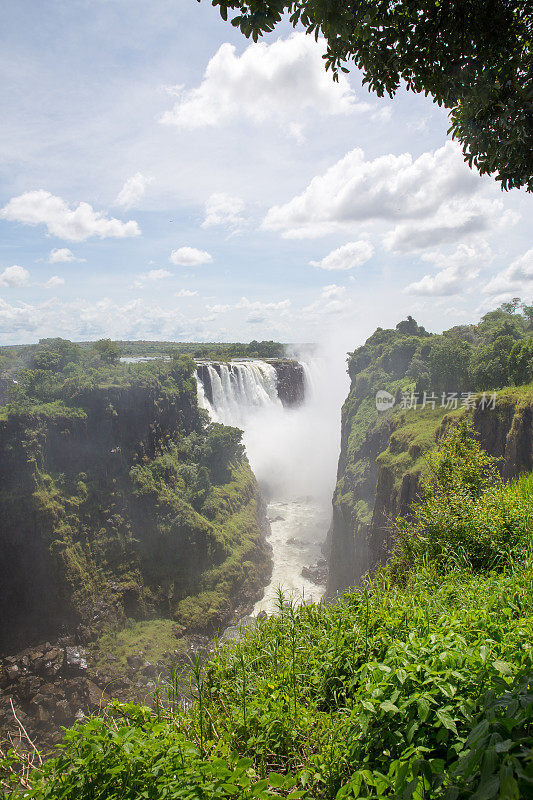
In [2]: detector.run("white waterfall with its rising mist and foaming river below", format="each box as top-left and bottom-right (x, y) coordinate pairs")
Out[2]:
(198, 359), (340, 614)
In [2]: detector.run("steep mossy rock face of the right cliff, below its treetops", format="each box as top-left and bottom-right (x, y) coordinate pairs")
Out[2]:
(327, 381), (533, 596)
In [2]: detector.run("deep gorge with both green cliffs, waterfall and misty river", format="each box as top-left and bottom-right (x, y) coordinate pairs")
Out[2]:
(0, 312), (533, 764)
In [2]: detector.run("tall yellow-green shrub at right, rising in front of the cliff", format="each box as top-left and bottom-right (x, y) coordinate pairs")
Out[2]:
(389, 421), (533, 577)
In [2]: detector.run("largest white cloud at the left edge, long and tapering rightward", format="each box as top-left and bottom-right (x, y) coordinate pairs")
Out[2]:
(0, 189), (141, 242)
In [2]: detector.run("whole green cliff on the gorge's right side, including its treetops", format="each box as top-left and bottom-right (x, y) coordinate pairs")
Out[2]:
(328, 300), (533, 594)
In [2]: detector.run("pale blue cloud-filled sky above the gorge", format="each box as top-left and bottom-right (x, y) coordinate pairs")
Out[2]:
(0, 0), (533, 346)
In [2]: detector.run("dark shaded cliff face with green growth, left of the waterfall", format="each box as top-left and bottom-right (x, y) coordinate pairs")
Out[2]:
(0, 381), (270, 650)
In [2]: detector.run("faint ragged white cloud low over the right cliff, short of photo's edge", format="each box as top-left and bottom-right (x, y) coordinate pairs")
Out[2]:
(404, 242), (492, 297)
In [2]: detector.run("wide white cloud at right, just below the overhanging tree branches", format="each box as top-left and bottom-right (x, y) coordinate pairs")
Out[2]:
(262, 142), (482, 238)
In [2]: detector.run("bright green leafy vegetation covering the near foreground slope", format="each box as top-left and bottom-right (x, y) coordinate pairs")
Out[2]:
(4, 425), (533, 800)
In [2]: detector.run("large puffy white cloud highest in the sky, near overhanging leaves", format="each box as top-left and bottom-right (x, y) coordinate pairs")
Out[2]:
(161, 32), (358, 136)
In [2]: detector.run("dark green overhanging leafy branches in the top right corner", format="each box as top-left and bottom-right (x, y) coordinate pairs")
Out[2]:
(212, 0), (533, 192)
